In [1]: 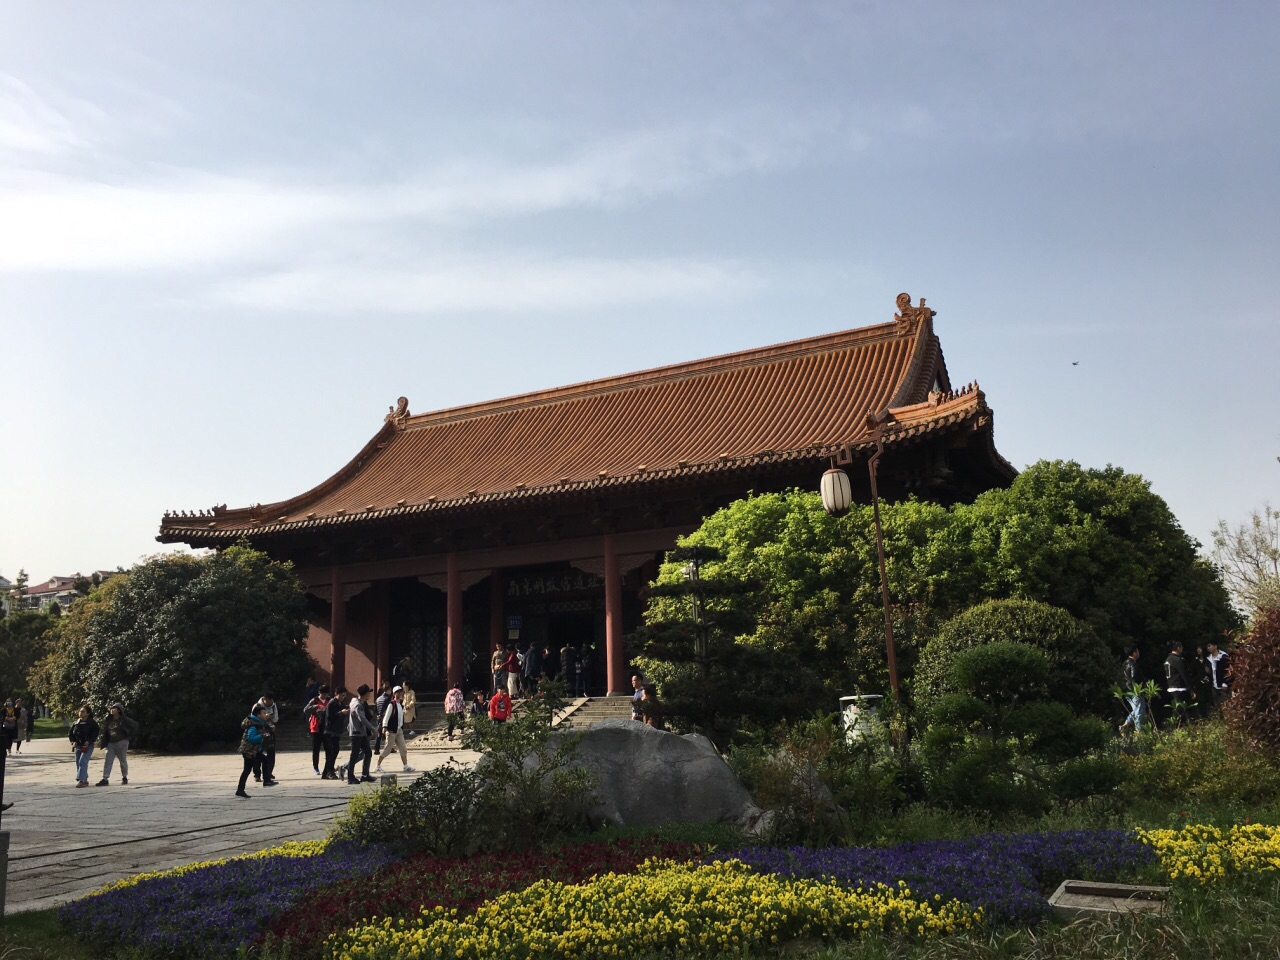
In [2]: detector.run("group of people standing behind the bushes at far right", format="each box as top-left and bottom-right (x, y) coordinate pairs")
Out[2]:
(1120, 640), (1231, 733)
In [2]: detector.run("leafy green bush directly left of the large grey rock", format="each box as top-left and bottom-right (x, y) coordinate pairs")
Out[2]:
(472, 689), (595, 850)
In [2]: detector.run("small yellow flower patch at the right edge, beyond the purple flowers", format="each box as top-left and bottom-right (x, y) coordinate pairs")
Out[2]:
(1138, 823), (1280, 883)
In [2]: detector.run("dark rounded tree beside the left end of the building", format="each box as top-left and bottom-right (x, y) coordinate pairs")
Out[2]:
(32, 544), (314, 748)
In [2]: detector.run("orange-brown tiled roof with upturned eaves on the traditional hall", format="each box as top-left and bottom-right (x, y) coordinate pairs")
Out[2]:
(159, 304), (986, 541)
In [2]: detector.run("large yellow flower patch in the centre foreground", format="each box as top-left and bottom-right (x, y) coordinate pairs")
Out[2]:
(328, 861), (982, 960)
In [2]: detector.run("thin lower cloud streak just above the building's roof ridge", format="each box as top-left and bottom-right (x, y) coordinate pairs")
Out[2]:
(214, 256), (767, 316)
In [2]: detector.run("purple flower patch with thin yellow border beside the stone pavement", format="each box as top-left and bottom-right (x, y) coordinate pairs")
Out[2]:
(58, 845), (394, 956)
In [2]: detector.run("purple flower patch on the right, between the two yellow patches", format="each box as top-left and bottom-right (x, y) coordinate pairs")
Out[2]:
(721, 831), (1156, 923)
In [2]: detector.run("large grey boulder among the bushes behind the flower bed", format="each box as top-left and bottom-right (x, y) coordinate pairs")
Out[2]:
(558, 718), (762, 831)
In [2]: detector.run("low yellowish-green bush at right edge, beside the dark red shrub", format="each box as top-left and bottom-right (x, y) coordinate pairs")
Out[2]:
(1119, 719), (1280, 809)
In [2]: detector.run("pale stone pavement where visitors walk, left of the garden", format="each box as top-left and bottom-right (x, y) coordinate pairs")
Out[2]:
(0, 740), (476, 913)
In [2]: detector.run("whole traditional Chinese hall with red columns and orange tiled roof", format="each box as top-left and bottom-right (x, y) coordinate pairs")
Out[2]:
(157, 294), (1015, 694)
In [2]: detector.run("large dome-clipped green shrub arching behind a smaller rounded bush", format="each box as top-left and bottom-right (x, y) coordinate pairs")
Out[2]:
(911, 600), (1115, 716)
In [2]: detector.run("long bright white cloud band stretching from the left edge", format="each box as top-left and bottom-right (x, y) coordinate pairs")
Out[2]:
(0, 104), (842, 273)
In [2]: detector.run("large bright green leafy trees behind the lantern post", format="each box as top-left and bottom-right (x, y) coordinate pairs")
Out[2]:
(629, 461), (1239, 716)
